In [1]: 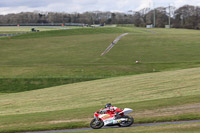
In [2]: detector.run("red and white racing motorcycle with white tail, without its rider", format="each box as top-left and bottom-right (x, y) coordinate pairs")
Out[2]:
(90, 108), (134, 129)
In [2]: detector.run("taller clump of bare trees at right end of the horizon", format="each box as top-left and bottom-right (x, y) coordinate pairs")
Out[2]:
(134, 5), (200, 29)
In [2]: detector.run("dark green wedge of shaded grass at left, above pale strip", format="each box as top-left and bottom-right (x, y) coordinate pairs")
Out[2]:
(0, 77), (101, 93)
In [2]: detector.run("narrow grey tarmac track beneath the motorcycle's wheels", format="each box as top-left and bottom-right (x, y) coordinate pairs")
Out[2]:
(24, 120), (200, 133)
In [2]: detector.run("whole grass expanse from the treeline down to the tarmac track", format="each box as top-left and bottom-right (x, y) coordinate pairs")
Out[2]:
(0, 27), (200, 132)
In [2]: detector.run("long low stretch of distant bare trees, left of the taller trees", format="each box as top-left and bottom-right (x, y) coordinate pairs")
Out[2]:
(0, 11), (134, 24)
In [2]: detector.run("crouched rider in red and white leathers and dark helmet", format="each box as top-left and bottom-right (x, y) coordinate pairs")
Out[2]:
(101, 103), (123, 119)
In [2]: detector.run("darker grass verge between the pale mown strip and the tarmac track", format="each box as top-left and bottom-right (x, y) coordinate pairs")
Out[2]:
(0, 95), (200, 132)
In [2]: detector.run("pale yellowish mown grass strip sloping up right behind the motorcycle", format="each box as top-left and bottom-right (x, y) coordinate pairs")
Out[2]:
(0, 68), (200, 115)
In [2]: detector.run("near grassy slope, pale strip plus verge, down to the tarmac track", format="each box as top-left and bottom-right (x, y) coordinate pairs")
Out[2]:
(0, 68), (200, 132)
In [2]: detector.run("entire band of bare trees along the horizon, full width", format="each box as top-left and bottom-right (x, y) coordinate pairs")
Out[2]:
(0, 5), (200, 29)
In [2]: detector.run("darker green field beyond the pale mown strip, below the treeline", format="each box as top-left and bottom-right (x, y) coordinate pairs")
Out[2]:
(0, 27), (200, 92)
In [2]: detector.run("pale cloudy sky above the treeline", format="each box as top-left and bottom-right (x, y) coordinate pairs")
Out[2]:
(0, 0), (200, 14)
